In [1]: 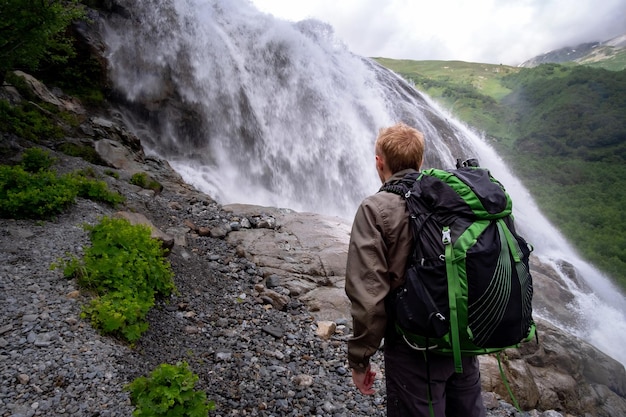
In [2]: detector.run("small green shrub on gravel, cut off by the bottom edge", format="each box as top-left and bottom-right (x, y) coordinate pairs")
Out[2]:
(125, 362), (215, 417)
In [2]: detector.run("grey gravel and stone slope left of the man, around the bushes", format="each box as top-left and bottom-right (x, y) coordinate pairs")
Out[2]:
(0, 145), (544, 417)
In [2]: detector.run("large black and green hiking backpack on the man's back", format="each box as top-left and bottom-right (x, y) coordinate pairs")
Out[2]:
(381, 160), (536, 373)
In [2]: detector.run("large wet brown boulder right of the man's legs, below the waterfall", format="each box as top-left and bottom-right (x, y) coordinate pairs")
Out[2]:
(479, 319), (626, 417)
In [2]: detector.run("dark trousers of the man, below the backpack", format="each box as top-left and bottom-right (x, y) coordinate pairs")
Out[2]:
(385, 341), (485, 417)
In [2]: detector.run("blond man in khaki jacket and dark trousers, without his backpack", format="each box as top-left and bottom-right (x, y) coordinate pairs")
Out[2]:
(346, 123), (485, 417)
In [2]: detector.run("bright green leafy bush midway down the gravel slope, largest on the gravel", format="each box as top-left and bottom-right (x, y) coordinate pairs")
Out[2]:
(63, 217), (175, 343)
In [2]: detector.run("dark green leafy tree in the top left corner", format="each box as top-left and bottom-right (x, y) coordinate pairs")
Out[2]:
(0, 0), (84, 83)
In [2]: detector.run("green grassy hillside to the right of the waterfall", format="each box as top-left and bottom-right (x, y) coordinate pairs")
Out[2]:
(376, 58), (626, 288)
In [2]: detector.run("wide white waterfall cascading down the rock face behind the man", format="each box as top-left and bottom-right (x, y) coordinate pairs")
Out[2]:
(102, 0), (626, 364)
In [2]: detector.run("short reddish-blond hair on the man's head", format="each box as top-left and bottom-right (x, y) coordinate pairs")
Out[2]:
(375, 123), (424, 174)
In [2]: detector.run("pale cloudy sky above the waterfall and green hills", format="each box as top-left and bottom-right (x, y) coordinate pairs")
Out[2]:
(251, 0), (626, 65)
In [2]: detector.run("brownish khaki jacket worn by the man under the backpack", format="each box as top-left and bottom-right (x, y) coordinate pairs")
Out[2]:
(346, 170), (415, 371)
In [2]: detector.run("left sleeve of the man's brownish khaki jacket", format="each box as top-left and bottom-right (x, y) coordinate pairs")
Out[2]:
(346, 199), (390, 371)
